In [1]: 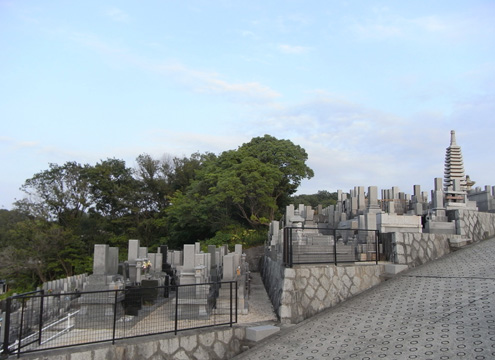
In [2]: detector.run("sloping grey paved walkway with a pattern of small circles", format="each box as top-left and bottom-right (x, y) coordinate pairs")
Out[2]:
(235, 239), (495, 360)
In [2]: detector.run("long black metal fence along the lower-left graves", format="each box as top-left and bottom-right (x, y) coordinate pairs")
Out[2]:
(0, 281), (237, 356)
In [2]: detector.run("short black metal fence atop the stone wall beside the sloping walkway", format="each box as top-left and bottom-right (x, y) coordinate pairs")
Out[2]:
(283, 227), (384, 267)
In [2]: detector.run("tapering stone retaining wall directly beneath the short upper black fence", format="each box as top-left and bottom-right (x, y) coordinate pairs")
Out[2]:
(262, 256), (385, 324)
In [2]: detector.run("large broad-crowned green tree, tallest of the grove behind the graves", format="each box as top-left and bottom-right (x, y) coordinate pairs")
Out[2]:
(167, 135), (313, 242)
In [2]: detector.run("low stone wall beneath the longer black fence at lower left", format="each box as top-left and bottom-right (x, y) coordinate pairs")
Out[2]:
(22, 326), (246, 360)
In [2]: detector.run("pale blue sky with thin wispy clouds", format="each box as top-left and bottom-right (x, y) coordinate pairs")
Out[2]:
(0, 0), (495, 209)
